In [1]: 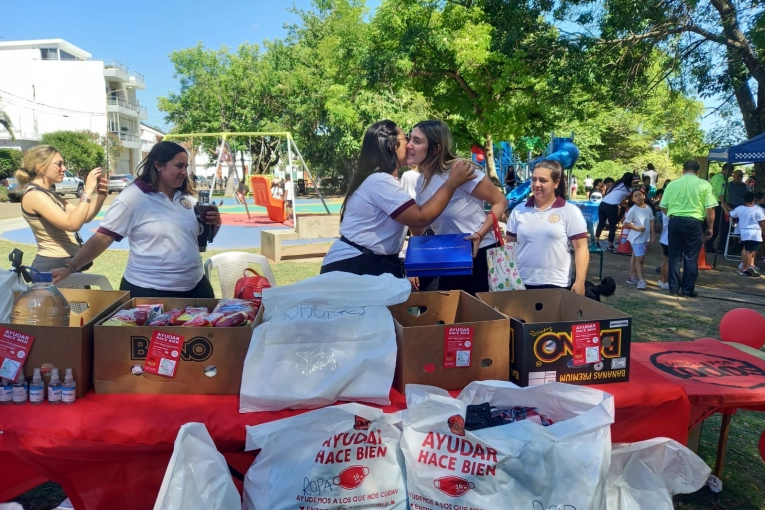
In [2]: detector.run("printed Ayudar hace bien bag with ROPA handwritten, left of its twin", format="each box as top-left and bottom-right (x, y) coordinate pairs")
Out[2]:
(243, 404), (406, 510)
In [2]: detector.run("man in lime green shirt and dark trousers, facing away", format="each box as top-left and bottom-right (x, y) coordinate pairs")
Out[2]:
(660, 160), (717, 297)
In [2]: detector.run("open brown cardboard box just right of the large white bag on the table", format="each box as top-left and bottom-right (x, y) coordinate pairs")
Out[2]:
(389, 291), (510, 393)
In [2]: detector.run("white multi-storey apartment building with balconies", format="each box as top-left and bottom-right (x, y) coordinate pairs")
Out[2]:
(0, 39), (147, 173)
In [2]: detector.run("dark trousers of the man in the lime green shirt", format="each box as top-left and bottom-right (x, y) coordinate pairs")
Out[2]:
(669, 216), (703, 294)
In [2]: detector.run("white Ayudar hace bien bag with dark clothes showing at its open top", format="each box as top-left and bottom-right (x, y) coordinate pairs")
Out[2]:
(401, 381), (614, 510)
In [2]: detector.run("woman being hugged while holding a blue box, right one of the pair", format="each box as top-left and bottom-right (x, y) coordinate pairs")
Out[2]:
(406, 120), (507, 294)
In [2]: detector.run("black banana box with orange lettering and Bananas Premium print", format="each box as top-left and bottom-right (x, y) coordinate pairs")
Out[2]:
(477, 289), (632, 386)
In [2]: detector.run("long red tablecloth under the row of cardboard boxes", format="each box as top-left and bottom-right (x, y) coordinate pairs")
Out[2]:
(0, 358), (690, 510)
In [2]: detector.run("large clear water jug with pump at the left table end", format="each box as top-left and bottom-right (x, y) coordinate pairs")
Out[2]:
(11, 271), (70, 327)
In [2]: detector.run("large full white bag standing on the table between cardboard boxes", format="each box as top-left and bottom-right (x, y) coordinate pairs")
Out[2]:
(239, 272), (411, 413)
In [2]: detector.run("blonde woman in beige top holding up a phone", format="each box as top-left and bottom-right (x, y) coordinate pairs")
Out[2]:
(16, 145), (108, 272)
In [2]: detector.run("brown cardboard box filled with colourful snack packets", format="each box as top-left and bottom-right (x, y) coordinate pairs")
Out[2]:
(94, 298), (263, 395)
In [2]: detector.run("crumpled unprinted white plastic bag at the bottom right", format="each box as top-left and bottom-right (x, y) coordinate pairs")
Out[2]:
(606, 437), (711, 510)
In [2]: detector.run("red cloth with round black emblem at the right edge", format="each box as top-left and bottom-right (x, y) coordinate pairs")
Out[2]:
(631, 339), (765, 428)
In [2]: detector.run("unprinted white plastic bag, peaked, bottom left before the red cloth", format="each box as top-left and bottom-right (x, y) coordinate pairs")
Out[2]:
(154, 423), (242, 510)
